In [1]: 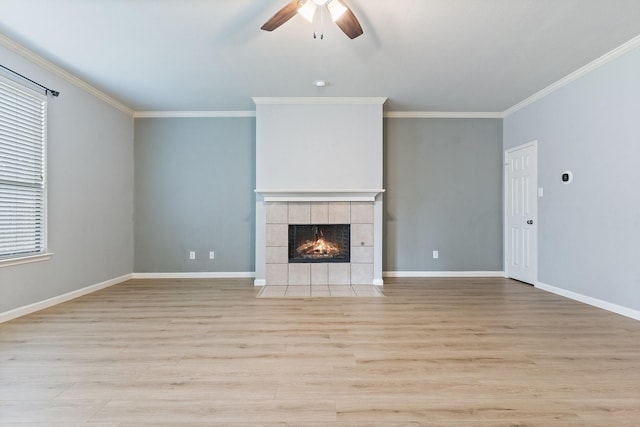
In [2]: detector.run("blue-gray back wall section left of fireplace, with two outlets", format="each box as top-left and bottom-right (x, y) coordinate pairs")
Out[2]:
(134, 118), (255, 273)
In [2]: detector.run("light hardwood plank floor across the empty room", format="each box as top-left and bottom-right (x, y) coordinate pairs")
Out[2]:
(0, 278), (640, 427)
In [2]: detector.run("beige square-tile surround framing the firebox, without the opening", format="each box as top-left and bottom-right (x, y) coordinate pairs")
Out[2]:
(265, 201), (374, 286)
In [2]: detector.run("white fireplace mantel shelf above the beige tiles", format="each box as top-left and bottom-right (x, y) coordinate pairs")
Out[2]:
(255, 188), (385, 202)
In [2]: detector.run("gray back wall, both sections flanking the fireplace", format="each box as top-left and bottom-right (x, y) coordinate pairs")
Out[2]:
(134, 118), (502, 273)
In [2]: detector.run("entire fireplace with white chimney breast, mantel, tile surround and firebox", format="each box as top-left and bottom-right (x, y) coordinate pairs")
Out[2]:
(253, 97), (386, 287)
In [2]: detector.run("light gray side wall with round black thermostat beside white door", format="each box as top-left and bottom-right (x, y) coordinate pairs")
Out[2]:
(504, 48), (640, 310)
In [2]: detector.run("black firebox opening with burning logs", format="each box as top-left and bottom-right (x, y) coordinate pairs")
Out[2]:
(289, 224), (351, 263)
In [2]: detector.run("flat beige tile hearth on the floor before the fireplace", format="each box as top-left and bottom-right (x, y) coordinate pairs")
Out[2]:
(257, 285), (384, 298)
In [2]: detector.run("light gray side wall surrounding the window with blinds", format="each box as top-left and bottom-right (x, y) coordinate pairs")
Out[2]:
(0, 46), (133, 313)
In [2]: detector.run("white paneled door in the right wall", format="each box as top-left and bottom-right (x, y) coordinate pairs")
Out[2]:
(505, 141), (538, 284)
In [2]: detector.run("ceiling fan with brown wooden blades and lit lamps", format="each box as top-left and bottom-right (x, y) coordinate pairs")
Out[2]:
(261, 0), (363, 39)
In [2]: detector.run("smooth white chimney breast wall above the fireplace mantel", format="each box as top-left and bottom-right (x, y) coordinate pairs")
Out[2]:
(254, 98), (386, 191)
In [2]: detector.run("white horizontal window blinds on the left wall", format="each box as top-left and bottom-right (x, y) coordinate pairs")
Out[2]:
(0, 78), (47, 260)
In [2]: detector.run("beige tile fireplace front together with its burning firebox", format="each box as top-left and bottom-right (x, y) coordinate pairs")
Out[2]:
(265, 201), (374, 286)
